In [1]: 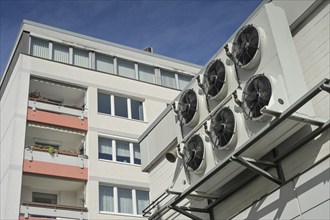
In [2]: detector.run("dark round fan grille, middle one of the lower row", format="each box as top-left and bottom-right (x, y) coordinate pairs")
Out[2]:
(212, 107), (235, 148)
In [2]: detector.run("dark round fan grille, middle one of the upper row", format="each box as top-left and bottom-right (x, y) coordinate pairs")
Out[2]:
(204, 60), (226, 97)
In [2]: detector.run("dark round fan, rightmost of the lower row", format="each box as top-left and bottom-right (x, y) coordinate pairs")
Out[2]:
(243, 74), (272, 119)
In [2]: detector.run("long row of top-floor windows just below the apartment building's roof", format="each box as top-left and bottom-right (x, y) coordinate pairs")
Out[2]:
(30, 37), (192, 90)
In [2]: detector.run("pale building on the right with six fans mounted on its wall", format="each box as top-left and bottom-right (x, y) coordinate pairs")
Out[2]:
(139, 0), (330, 220)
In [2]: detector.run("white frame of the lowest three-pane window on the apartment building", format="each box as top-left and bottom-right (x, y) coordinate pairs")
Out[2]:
(98, 182), (150, 216)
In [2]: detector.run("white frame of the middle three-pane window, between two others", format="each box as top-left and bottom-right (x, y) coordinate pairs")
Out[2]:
(97, 134), (141, 166)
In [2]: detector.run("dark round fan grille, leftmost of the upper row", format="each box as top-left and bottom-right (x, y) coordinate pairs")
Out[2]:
(179, 89), (197, 124)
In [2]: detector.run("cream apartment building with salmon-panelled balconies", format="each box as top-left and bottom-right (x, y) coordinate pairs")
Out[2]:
(0, 21), (201, 219)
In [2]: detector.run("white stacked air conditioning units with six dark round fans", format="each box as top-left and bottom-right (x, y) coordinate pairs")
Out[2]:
(173, 3), (313, 193)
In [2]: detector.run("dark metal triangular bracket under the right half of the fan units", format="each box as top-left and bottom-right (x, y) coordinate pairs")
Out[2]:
(230, 156), (284, 185)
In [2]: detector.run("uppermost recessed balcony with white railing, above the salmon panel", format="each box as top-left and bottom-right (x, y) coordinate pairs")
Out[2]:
(28, 78), (87, 119)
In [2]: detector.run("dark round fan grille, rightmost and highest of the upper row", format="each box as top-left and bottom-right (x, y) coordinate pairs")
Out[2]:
(234, 25), (259, 66)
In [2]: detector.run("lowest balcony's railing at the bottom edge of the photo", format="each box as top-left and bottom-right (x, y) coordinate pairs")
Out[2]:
(20, 201), (88, 219)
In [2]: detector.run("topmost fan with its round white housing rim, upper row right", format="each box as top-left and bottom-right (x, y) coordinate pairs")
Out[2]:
(232, 24), (262, 69)
